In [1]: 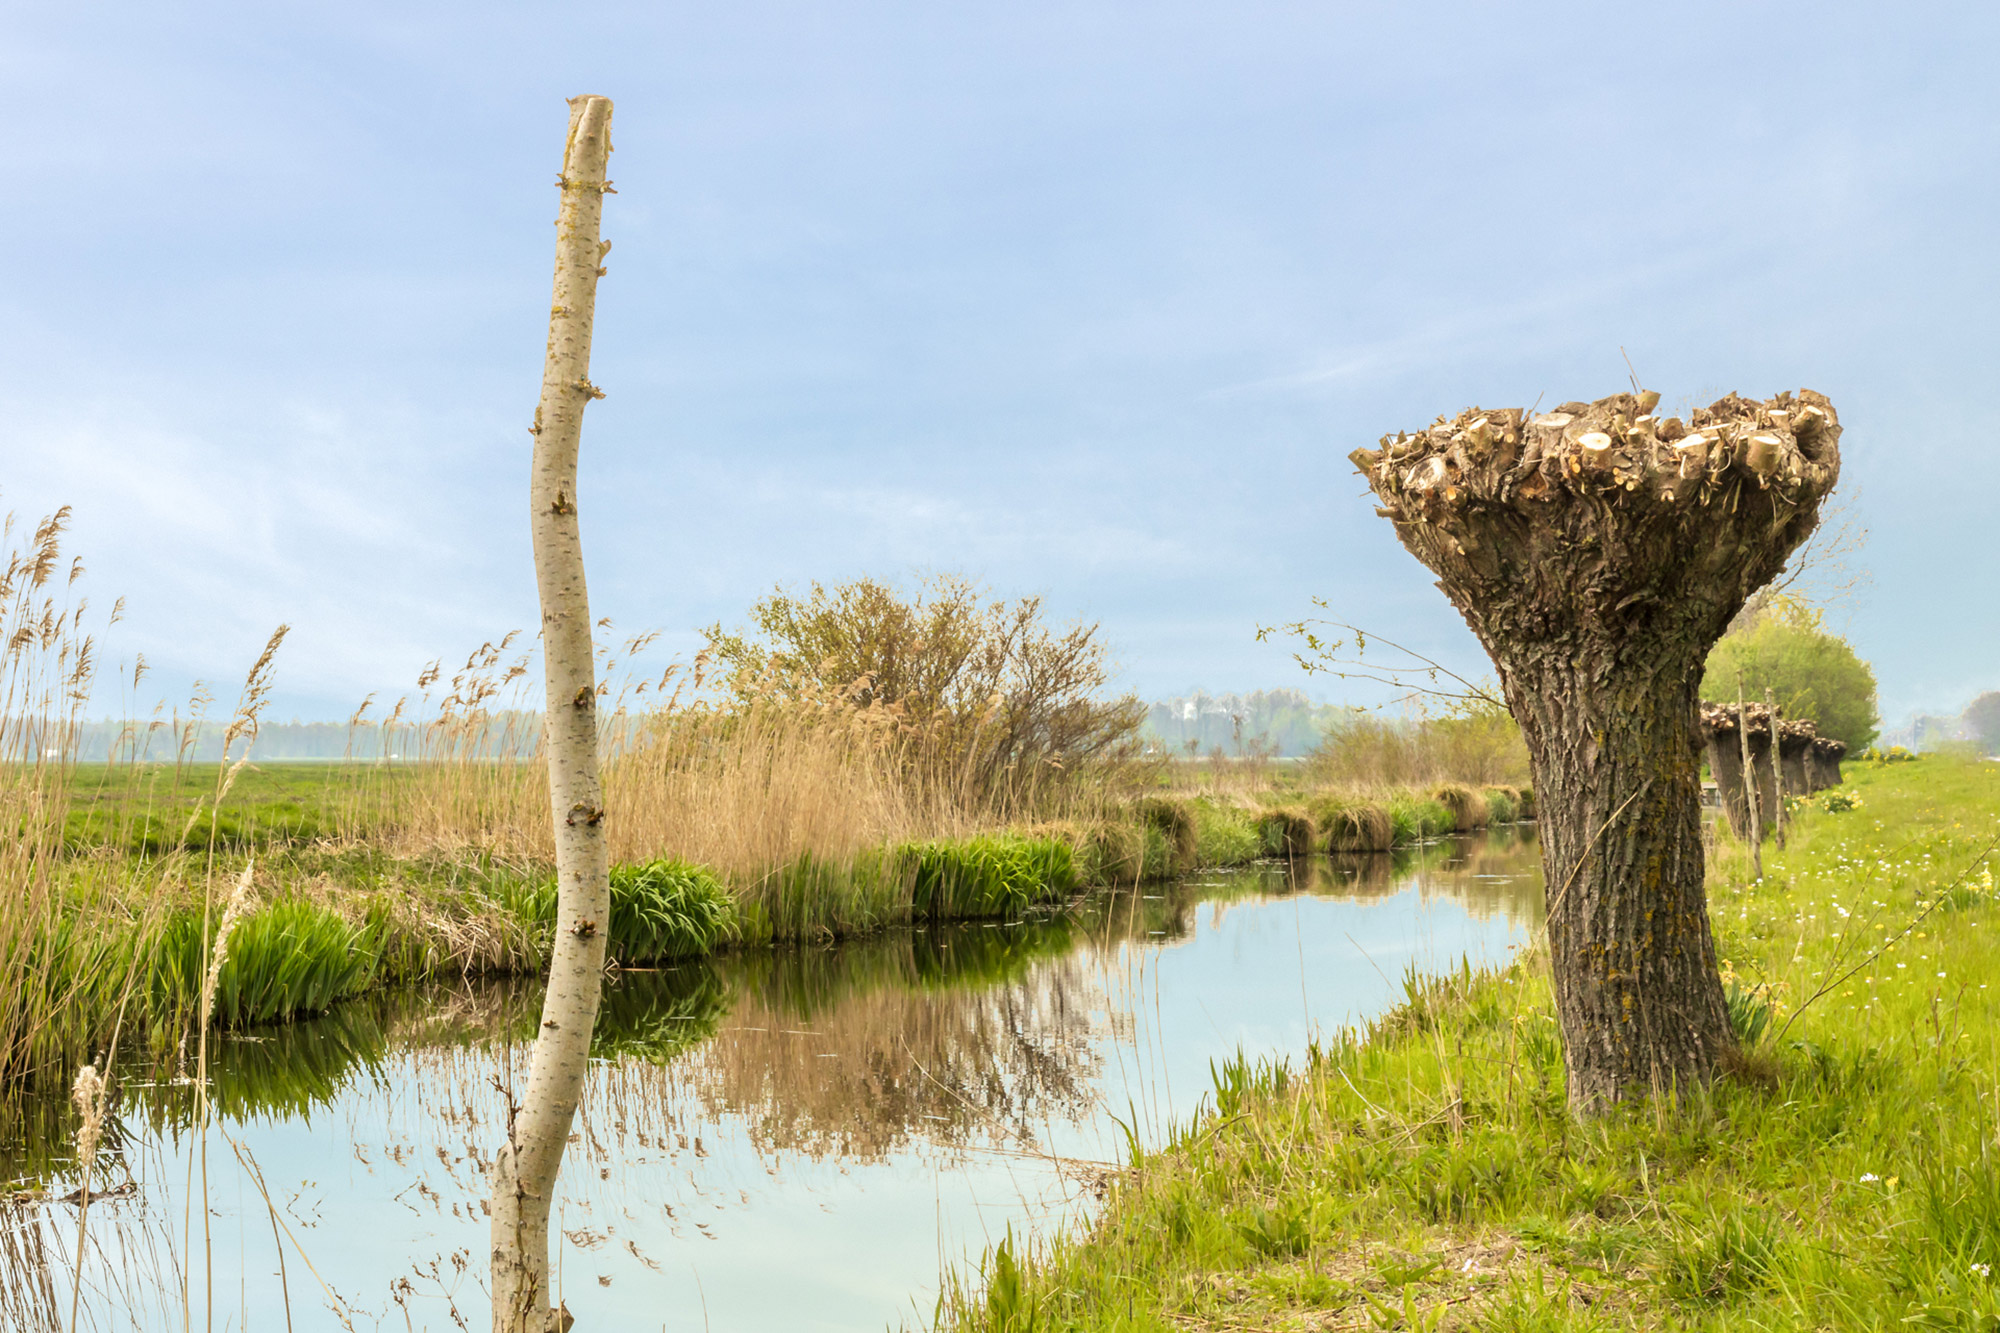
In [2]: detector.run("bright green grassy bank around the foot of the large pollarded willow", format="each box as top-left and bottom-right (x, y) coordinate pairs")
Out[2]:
(938, 759), (2000, 1333)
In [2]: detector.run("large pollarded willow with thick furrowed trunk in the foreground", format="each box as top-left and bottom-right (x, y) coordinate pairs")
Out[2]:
(1350, 390), (1840, 1111)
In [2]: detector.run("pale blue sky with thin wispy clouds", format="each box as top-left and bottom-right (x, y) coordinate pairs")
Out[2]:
(0, 2), (2000, 725)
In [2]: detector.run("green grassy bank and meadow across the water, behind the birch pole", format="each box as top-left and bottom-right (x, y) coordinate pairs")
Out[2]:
(16, 756), (1524, 1071)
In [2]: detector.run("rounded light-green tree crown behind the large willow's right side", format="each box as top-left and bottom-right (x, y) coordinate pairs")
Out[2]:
(1702, 596), (1876, 753)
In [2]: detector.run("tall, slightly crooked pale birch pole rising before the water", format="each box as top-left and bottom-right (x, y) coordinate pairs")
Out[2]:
(490, 96), (612, 1333)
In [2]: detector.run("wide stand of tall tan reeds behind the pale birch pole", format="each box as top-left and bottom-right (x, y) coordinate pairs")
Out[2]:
(348, 634), (1008, 887)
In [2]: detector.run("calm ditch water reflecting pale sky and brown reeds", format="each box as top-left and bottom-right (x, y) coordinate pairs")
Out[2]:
(0, 831), (1542, 1333)
